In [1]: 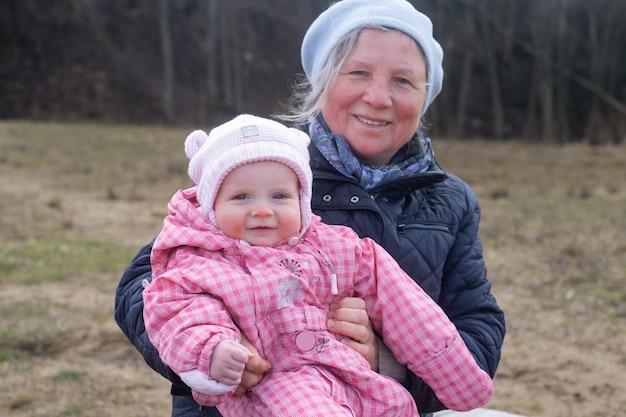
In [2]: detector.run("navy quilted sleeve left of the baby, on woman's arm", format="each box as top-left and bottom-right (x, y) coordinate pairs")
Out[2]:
(115, 241), (188, 391)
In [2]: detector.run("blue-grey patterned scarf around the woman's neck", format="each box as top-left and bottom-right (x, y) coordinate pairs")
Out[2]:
(309, 115), (434, 191)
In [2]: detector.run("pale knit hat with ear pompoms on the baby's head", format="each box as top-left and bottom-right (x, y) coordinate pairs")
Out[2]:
(185, 114), (313, 235)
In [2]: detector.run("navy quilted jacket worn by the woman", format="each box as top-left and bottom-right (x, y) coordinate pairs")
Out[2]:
(115, 138), (505, 412)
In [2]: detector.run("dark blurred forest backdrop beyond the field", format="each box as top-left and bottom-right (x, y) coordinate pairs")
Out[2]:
(0, 0), (626, 143)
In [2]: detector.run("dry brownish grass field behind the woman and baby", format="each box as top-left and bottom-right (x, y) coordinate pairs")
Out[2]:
(0, 121), (626, 417)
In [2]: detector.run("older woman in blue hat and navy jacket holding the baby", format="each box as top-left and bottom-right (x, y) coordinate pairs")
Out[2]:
(116, 0), (505, 416)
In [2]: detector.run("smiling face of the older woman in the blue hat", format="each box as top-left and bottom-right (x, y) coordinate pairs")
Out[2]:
(322, 29), (426, 165)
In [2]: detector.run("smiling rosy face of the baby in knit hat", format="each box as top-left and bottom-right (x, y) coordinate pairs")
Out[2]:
(214, 161), (301, 246)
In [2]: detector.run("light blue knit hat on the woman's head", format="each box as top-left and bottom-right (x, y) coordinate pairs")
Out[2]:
(301, 0), (443, 114)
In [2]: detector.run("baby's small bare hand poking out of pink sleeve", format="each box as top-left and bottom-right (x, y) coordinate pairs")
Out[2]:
(209, 340), (254, 386)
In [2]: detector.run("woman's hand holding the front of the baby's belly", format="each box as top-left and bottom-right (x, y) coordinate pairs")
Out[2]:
(326, 297), (379, 372)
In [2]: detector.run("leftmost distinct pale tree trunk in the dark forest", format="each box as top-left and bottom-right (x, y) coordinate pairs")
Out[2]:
(159, 0), (174, 122)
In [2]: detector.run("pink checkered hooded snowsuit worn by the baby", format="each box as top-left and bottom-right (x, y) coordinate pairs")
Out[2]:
(143, 188), (493, 417)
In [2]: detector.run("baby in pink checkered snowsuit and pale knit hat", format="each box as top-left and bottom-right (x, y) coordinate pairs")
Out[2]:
(143, 115), (493, 417)
